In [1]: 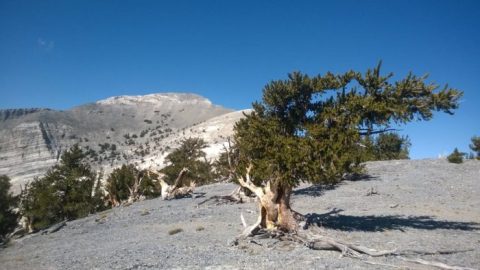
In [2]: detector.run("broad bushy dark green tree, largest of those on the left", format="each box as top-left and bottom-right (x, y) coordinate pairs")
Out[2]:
(20, 145), (103, 230)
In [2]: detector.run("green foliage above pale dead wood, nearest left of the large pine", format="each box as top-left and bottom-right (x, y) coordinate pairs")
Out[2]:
(161, 138), (214, 185)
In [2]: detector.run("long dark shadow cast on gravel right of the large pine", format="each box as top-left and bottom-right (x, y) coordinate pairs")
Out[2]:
(306, 209), (480, 232)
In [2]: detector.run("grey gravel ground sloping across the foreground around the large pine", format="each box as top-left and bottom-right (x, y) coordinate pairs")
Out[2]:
(0, 160), (480, 269)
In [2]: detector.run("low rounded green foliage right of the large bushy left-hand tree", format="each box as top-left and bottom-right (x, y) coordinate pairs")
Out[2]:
(105, 164), (160, 203)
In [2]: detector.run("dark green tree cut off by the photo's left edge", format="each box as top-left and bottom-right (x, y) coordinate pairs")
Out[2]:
(0, 175), (18, 242)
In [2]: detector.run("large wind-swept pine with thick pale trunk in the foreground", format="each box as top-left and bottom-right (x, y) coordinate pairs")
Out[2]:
(234, 64), (462, 232)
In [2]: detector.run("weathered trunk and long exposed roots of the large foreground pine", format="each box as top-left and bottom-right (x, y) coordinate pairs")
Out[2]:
(233, 163), (469, 270)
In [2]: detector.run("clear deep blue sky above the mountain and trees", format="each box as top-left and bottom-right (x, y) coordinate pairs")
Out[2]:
(0, 0), (480, 158)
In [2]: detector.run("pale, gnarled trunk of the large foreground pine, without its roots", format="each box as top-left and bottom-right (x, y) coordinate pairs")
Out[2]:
(238, 164), (301, 234)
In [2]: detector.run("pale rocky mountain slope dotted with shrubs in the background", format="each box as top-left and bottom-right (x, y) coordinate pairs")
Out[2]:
(0, 93), (243, 191)
